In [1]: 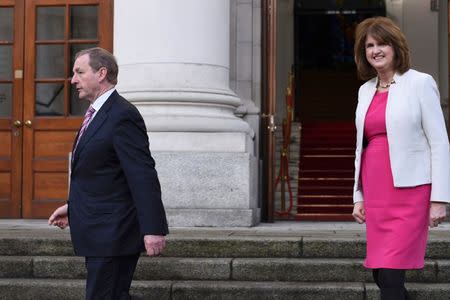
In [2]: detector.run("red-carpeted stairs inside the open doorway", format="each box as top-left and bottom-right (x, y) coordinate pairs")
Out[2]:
(296, 121), (356, 221)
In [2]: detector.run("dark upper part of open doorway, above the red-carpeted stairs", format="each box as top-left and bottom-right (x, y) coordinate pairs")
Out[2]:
(294, 0), (386, 122)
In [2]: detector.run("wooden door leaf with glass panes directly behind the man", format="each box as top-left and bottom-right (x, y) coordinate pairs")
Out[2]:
(22, 0), (113, 218)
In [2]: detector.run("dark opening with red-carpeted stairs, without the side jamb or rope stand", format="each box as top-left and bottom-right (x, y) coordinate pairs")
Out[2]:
(294, 0), (386, 221)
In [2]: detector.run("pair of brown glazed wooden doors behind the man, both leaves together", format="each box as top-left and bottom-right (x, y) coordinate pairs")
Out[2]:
(0, 0), (113, 218)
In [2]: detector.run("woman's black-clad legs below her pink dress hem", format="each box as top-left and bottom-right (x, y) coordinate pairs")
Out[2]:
(372, 269), (411, 300)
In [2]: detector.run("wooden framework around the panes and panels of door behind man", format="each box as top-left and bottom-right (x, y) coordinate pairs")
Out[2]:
(21, 0), (114, 218)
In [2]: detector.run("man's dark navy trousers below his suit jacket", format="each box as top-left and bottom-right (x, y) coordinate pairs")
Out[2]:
(85, 254), (140, 300)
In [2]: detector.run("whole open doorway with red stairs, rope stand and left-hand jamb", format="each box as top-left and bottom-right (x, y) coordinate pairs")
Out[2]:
(262, 0), (386, 221)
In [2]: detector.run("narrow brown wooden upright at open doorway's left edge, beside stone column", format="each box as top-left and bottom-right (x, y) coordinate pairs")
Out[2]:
(261, 0), (277, 222)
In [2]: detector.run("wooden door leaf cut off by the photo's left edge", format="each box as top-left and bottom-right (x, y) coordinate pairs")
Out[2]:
(0, 0), (24, 218)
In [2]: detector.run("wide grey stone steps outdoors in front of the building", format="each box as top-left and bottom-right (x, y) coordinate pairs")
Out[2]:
(0, 222), (450, 300)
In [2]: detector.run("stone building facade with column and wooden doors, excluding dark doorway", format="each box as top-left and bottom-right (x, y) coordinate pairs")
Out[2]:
(0, 0), (449, 226)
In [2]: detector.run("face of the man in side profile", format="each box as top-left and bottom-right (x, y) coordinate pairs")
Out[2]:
(71, 54), (101, 102)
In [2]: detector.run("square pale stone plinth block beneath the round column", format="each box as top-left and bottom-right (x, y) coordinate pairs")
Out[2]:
(153, 151), (260, 227)
